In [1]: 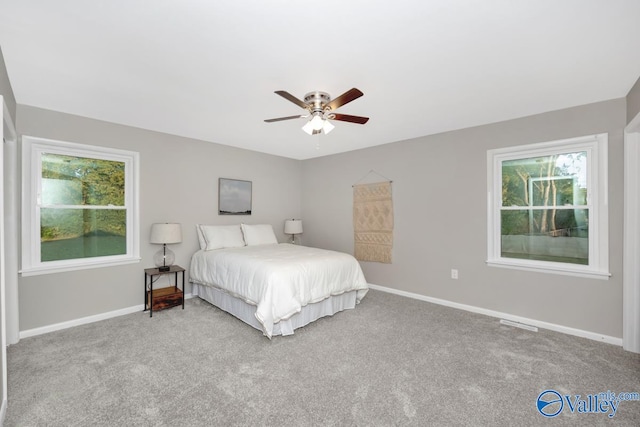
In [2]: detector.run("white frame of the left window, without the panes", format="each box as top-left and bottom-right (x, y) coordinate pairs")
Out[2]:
(20, 135), (140, 276)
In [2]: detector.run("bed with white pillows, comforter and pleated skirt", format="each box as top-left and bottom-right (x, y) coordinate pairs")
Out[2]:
(189, 224), (368, 338)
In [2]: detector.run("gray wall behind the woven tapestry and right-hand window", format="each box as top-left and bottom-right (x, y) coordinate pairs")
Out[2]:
(302, 99), (626, 337)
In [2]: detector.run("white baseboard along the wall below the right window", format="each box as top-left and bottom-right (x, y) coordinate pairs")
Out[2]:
(369, 283), (622, 346)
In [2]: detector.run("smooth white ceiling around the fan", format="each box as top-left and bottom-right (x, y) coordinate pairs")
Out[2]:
(0, 0), (640, 159)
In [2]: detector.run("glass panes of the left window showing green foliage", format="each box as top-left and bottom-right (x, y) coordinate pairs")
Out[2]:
(40, 153), (127, 261)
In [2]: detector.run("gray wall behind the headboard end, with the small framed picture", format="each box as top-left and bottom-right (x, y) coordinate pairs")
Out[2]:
(17, 105), (301, 331)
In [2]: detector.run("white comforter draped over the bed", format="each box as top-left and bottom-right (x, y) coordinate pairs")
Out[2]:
(189, 243), (368, 337)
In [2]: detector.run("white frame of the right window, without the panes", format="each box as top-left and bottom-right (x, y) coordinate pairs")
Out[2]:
(487, 133), (611, 279)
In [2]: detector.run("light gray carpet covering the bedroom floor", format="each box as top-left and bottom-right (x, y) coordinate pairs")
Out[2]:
(5, 291), (640, 427)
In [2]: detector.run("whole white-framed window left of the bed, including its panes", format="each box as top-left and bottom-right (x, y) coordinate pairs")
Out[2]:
(21, 136), (140, 276)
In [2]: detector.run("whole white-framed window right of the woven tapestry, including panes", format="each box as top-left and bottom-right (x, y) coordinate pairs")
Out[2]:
(487, 134), (609, 278)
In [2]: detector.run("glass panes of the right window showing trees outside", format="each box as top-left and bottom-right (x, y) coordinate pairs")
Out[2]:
(500, 152), (589, 264)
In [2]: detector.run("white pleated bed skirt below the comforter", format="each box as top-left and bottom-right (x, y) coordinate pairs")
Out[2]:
(191, 282), (357, 336)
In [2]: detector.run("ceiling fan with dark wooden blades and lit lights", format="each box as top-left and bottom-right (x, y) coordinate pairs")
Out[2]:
(265, 88), (369, 135)
